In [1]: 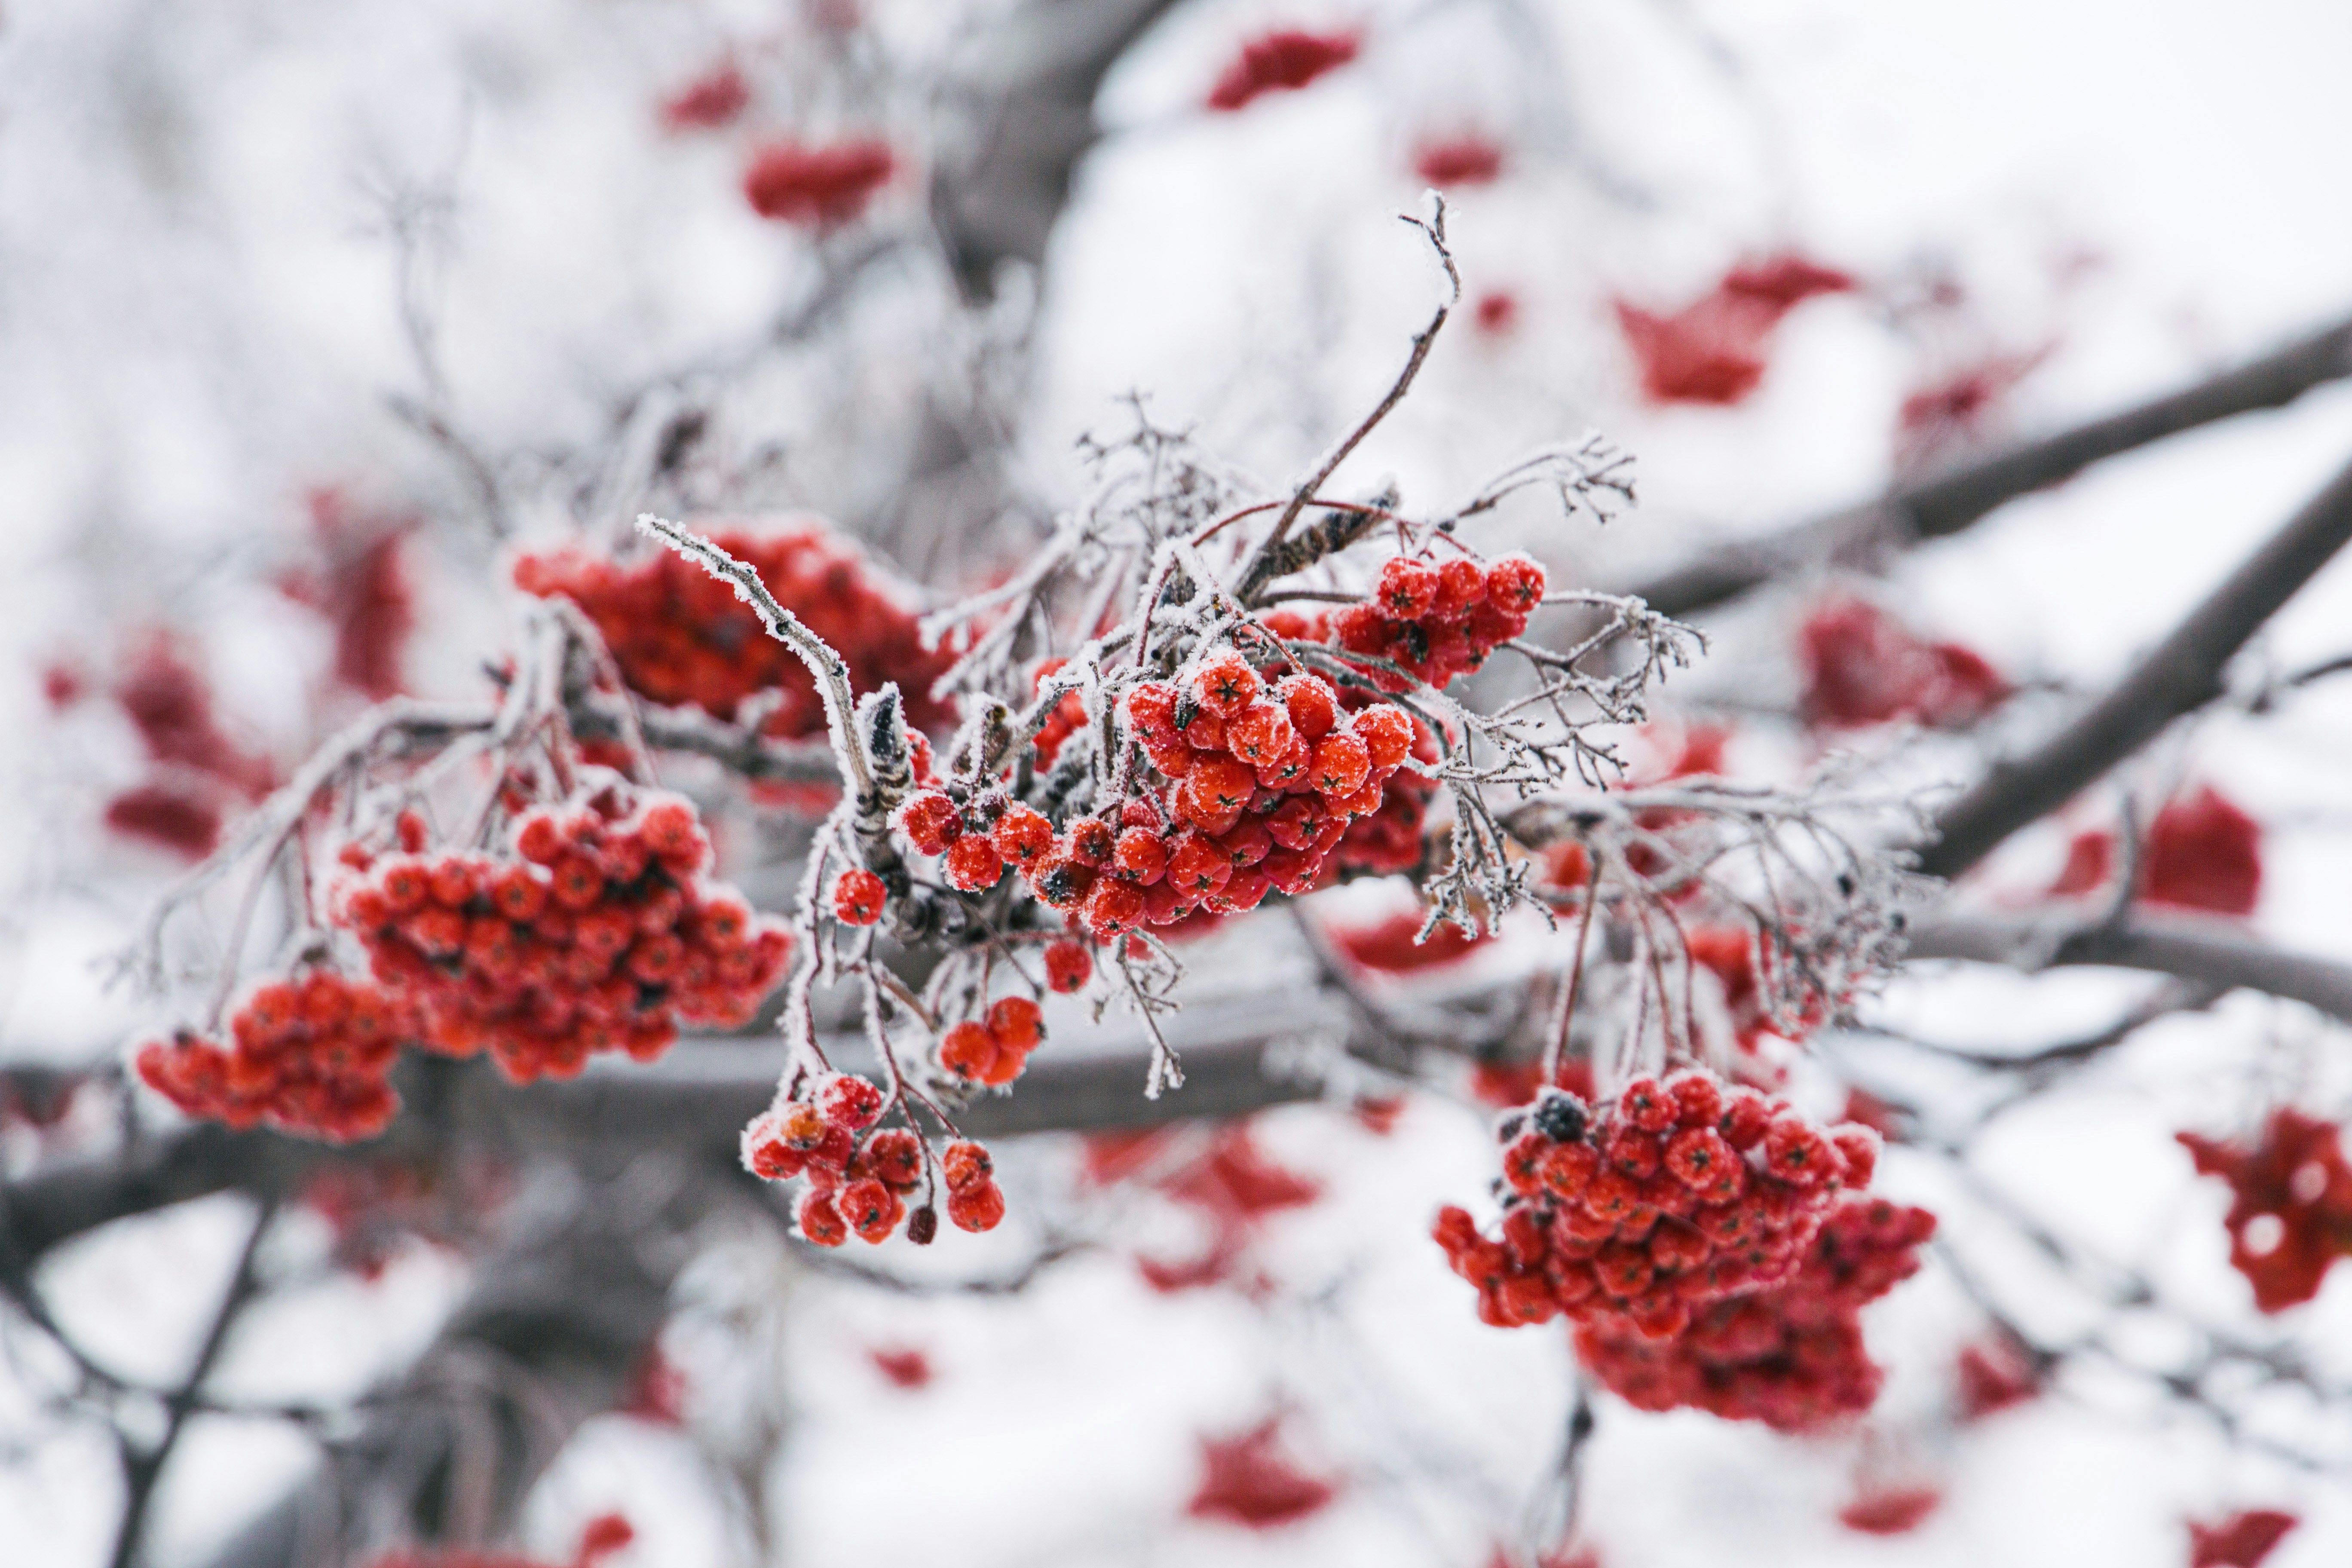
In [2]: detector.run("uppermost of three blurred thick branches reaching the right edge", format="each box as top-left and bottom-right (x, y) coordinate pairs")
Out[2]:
(1637, 320), (2352, 616)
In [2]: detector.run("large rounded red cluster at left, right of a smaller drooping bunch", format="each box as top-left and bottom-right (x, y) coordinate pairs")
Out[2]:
(334, 781), (790, 1081)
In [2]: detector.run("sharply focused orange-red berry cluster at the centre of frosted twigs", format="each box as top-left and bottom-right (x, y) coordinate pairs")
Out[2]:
(898, 651), (1416, 940)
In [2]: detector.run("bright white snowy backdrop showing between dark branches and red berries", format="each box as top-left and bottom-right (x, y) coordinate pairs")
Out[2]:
(0, 0), (2352, 1568)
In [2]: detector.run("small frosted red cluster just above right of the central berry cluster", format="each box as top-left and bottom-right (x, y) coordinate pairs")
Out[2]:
(1326, 555), (1545, 691)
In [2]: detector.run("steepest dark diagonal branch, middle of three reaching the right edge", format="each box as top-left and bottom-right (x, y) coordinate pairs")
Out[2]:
(1919, 444), (2352, 877)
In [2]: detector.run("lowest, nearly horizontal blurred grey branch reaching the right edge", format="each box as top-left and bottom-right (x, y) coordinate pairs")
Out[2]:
(1910, 915), (2352, 1023)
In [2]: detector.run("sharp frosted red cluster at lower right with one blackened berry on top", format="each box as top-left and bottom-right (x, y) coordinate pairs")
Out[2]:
(1435, 1070), (1879, 1340)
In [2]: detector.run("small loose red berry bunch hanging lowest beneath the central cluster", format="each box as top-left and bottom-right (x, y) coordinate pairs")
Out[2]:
(743, 1072), (1004, 1246)
